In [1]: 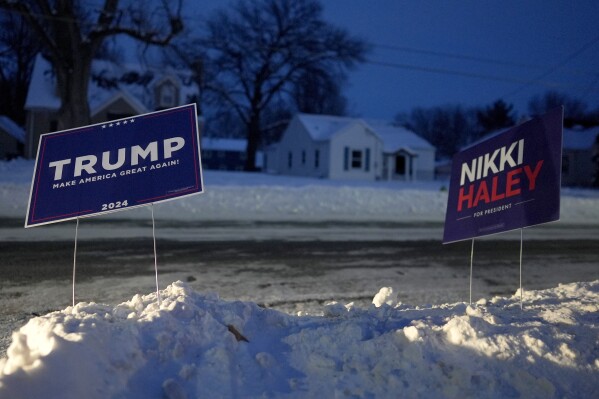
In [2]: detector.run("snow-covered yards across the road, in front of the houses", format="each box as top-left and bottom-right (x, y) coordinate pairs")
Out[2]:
(0, 160), (599, 230)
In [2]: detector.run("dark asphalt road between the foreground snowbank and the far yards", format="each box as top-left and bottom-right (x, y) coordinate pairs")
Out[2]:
(0, 237), (599, 356)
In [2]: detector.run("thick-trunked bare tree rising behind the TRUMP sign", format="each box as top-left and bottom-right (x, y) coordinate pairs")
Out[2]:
(0, 0), (183, 129)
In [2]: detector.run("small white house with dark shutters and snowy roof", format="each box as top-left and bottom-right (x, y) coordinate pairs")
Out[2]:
(264, 114), (435, 180)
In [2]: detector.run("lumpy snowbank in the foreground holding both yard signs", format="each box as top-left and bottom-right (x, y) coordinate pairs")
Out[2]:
(0, 281), (599, 399)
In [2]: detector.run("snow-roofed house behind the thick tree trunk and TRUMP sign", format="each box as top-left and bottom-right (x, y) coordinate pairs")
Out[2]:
(25, 55), (198, 158)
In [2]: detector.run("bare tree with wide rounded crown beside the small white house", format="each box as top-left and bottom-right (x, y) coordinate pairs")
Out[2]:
(202, 0), (366, 170)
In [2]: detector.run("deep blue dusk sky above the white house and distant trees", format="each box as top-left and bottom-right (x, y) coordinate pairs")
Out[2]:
(188, 0), (599, 119)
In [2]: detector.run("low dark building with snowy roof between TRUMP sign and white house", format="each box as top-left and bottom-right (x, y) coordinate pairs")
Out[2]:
(200, 137), (263, 170)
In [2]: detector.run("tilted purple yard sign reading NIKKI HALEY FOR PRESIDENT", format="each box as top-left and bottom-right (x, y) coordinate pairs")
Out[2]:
(443, 107), (563, 243)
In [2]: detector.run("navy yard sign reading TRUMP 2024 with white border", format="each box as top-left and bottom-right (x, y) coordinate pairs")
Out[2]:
(25, 104), (203, 227)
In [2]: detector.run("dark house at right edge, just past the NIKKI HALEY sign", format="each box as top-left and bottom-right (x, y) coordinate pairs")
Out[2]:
(562, 127), (599, 186)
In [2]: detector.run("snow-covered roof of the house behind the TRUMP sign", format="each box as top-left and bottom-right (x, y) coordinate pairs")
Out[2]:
(25, 54), (197, 115)
